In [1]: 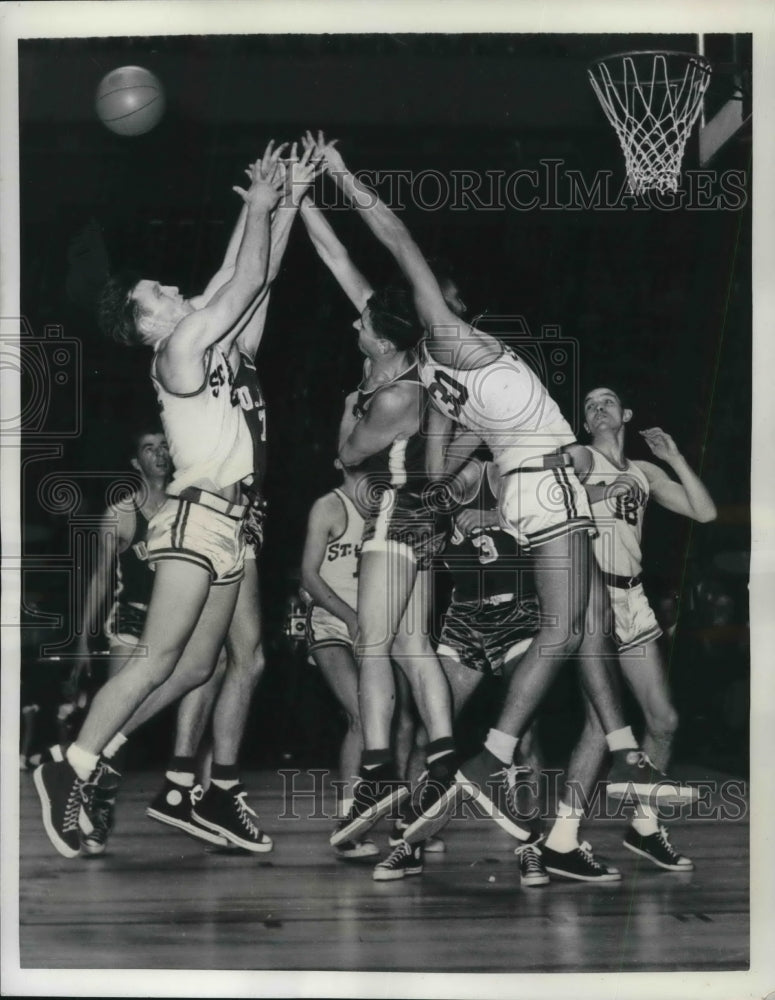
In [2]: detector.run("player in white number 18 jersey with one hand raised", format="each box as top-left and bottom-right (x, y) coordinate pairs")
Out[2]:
(541, 387), (716, 881)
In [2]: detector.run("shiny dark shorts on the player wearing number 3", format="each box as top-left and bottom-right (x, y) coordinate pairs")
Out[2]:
(436, 594), (541, 675)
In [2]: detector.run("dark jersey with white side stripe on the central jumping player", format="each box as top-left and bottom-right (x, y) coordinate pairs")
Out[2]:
(353, 361), (429, 501)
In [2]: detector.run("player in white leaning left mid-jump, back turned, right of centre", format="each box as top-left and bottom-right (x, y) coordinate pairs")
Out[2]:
(318, 134), (693, 856)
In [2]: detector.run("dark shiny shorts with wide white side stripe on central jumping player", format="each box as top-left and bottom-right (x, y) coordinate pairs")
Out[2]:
(361, 489), (451, 570)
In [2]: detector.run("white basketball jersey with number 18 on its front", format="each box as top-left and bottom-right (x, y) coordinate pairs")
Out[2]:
(584, 447), (649, 576)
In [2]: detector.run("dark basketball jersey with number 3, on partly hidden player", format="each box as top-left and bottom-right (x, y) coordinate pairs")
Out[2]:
(442, 470), (535, 603)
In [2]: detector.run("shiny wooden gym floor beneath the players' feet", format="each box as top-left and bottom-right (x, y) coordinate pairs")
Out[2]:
(20, 769), (749, 972)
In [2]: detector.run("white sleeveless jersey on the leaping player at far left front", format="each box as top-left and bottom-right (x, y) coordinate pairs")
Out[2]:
(151, 344), (254, 496)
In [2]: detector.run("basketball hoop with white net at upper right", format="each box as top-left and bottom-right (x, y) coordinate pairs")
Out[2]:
(587, 52), (711, 195)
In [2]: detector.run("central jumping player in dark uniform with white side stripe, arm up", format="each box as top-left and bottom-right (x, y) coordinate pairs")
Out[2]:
(301, 189), (455, 864)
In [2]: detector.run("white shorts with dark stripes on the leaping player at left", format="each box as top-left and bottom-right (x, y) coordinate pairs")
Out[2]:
(148, 490), (245, 585)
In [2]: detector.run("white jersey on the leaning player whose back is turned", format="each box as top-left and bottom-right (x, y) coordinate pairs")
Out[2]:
(420, 344), (576, 475)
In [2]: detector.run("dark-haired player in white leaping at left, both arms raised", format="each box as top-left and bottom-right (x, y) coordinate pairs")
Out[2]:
(35, 143), (314, 857)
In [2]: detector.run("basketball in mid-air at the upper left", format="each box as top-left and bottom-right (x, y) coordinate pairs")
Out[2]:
(94, 66), (165, 135)
